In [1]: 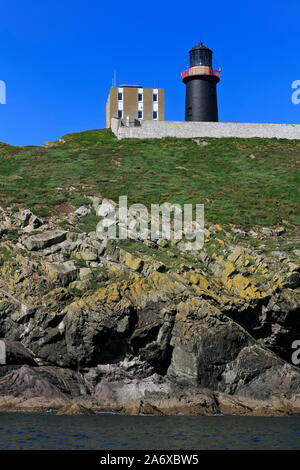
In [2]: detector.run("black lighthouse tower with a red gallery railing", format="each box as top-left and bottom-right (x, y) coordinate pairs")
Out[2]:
(181, 42), (221, 122)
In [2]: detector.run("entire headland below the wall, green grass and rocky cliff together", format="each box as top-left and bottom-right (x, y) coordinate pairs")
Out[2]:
(0, 130), (300, 414)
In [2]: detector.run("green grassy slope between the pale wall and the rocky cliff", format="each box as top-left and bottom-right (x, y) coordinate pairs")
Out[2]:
(0, 130), (300, 226)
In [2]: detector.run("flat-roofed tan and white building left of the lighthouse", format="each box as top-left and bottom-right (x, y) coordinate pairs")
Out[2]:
(105, 85), (165, 127)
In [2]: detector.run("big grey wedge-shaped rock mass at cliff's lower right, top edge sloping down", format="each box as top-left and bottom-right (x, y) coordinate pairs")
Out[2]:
(168, 299), (300, 399)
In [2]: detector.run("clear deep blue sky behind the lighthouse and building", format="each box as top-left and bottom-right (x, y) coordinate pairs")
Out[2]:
(0, 0), (300, 145)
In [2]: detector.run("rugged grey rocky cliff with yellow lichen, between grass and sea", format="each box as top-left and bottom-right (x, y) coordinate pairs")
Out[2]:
(0, 197), (300, 414)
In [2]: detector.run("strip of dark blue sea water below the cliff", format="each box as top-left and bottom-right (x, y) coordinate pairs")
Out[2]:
(0, 412), (300, 450)
